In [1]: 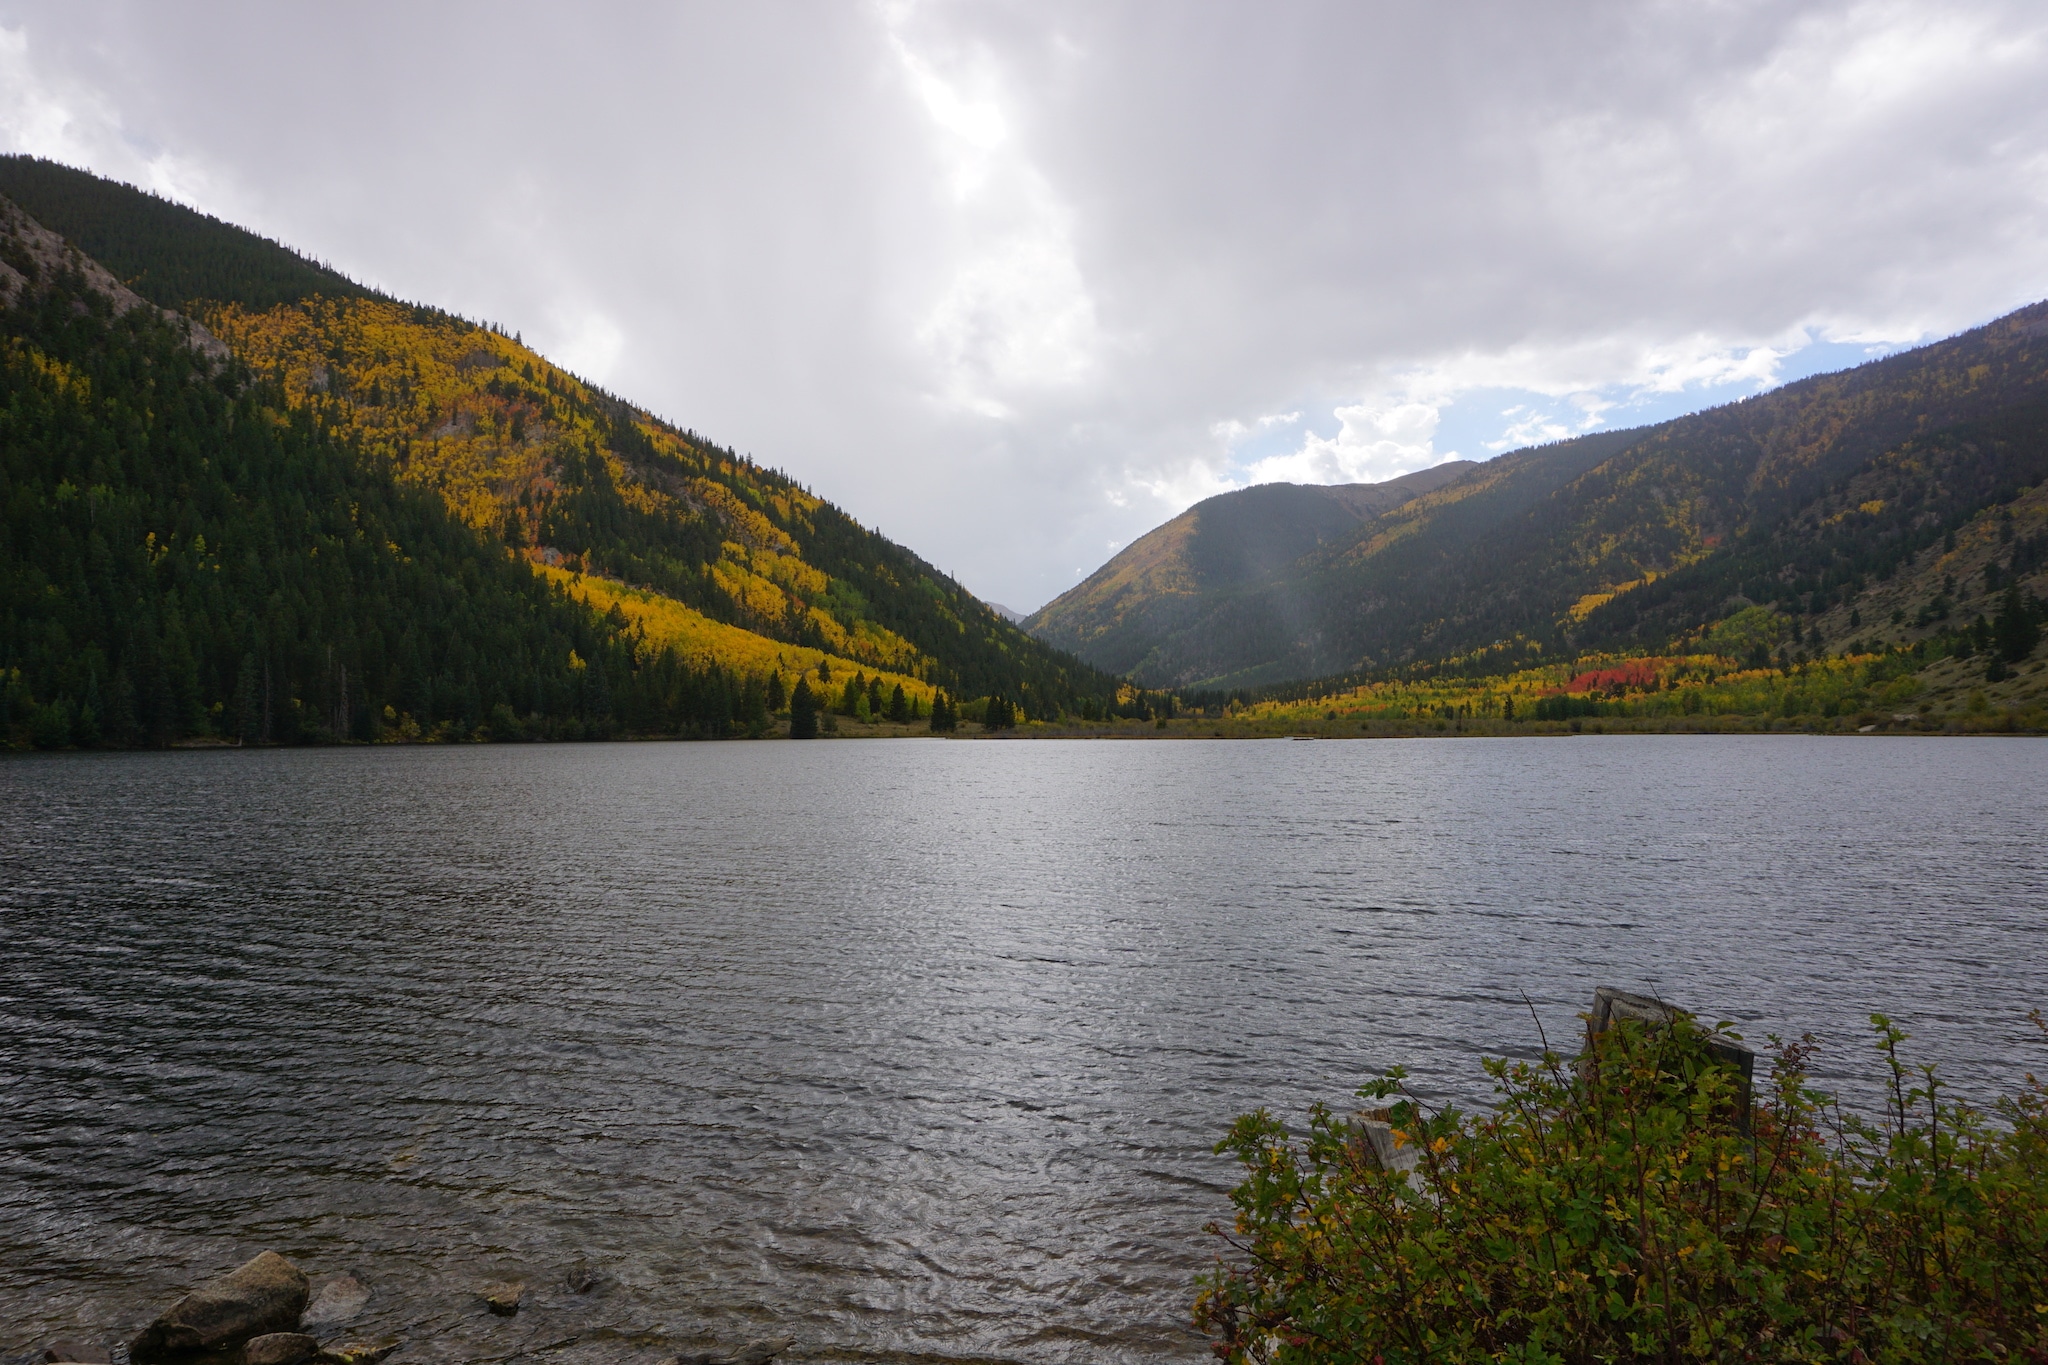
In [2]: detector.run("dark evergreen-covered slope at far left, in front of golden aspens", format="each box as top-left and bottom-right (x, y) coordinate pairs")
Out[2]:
(0, 203), (633, 747)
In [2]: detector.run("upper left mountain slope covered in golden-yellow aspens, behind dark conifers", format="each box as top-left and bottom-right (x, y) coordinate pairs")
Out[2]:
(0, 158), (1114, 749)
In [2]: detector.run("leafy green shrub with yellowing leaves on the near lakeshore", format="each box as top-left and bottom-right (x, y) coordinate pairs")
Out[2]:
(1196, 1011), (2048, 1365)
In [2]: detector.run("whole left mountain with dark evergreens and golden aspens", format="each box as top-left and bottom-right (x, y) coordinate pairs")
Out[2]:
(0, 158), (1116, 743)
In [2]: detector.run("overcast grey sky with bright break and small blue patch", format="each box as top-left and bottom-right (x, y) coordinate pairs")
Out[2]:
(0, 0), (2048, 610)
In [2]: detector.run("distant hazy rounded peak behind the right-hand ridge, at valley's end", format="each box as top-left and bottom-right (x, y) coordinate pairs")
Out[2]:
(1024, 460), (1477, 684)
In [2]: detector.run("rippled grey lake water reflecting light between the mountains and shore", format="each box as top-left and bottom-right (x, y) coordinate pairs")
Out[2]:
(0, 737), (2048, 1365)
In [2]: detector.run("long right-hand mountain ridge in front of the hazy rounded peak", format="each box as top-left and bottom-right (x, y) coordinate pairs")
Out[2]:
(1034, 303), (2048, 688)
